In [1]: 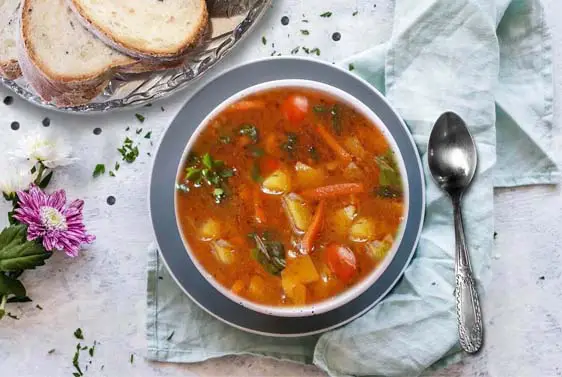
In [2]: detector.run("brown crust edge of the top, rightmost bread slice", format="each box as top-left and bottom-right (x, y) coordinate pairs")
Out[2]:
(66, 0), (209, 60)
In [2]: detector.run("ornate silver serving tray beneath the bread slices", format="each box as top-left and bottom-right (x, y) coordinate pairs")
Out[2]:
(0, 0), (272, 114)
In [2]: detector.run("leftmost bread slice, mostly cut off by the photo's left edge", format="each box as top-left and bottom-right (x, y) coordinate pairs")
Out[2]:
(0, 0), (21, 80)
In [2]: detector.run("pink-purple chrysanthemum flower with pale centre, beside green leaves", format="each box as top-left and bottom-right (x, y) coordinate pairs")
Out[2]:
(14, 185), (95, 257)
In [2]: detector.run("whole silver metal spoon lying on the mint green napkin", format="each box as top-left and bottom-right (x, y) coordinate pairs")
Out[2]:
(428, 112), (483, 353)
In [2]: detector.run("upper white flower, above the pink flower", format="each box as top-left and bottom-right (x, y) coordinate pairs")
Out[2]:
(12, 132), (77, 169)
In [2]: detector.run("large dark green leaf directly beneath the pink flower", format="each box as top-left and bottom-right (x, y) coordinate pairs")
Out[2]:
(0, 224), (52, 272)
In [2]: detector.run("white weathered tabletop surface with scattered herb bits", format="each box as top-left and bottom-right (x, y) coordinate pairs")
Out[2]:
(0, 0), (562, 377)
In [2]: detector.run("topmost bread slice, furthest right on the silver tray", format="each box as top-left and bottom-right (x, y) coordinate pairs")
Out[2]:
(67, 0), (209, 60)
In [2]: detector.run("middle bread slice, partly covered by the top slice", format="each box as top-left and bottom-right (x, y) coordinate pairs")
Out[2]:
(18, 0), (180, 106)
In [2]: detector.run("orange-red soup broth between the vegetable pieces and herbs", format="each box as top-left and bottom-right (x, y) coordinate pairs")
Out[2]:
(177, 88), (403, 306)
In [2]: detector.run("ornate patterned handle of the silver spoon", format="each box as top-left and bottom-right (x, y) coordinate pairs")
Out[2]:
(453, 197), (483, 353)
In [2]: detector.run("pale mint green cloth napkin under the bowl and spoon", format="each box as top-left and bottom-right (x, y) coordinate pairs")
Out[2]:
(147, 0), (558, 376)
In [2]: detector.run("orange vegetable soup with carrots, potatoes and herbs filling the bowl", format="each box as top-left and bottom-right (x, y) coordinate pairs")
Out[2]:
(176, 88), (404, 306)
